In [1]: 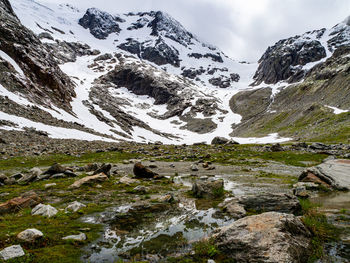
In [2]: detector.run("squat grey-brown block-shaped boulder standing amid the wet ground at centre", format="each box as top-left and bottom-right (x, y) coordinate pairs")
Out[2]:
(192, 178), (224, 198)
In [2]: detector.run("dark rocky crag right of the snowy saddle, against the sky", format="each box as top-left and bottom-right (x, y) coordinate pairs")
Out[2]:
(254, 30), (326, 85)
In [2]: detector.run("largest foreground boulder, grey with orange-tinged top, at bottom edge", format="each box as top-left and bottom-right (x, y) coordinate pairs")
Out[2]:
(211, 212), (311, 263)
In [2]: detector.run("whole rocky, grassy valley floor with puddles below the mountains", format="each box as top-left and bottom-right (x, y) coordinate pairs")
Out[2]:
(0, 139), (350, 262)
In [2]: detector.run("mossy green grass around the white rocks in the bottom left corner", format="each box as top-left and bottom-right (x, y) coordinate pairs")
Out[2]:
(0, 207), (101, 263)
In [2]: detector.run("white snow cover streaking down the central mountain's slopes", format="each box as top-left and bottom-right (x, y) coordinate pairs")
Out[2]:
(0, 0), (288, 144)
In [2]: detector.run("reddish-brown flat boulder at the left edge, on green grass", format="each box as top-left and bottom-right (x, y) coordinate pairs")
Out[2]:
(0, 191), (41, 215)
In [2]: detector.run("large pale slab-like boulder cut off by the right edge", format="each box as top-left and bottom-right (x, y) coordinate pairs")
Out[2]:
(299, 159), (350, 191)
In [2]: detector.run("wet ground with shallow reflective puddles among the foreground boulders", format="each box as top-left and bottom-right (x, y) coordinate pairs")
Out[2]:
(79, 162), (350, 263)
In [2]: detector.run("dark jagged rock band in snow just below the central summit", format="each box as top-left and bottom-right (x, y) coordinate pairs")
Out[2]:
(118, 38), (180, 67)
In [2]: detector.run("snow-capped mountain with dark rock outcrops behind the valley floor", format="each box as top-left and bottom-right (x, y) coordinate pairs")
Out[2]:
(0, 0), (350, 144)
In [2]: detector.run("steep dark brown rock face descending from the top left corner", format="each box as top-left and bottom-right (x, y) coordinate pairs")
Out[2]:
(0, 0), (75, 109)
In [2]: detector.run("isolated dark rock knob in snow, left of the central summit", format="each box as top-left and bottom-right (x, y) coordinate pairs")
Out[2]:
(79, 8), (124, 39)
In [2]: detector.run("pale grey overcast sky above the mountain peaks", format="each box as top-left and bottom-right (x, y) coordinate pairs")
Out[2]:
(39, 0), (350, 61)
